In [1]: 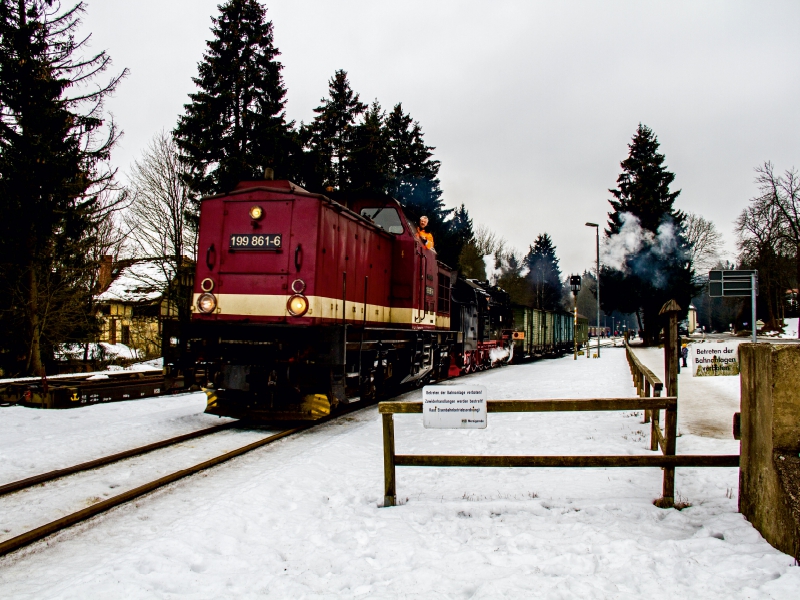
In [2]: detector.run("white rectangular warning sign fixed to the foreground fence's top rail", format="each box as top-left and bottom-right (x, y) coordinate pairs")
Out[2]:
(422, 385), (487, 429)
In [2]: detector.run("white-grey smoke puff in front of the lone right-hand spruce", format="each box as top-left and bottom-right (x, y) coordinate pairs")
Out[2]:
(600, 212), (682, 286)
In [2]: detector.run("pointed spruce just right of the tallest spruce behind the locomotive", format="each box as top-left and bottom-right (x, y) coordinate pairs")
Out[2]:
(306, 69), (368, 192)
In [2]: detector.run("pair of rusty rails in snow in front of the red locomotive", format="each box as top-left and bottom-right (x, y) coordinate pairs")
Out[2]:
(0, 422), (310, 556)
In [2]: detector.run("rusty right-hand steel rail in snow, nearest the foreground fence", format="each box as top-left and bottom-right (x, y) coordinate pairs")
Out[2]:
(0, 425), (312, 556)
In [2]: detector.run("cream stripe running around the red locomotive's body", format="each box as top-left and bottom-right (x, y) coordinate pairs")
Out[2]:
(192, 294), (450, 329)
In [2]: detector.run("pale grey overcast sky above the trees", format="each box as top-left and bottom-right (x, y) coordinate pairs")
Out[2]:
(84, 0), (800, 274)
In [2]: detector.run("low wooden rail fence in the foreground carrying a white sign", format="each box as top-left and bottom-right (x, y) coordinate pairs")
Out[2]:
(378, 396), (739, 508)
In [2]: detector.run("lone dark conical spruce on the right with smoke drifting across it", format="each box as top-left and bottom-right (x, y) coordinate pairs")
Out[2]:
(600, 123), (696, 344)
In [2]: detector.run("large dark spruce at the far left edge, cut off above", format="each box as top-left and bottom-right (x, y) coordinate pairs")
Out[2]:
(0, 0), (124, 375)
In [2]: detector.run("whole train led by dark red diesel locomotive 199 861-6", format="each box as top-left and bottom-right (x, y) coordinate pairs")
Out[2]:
(164, 180), (573, 421)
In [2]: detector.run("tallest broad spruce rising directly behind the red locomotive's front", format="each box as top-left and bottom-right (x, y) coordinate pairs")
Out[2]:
(173, 0), (300, 205)
